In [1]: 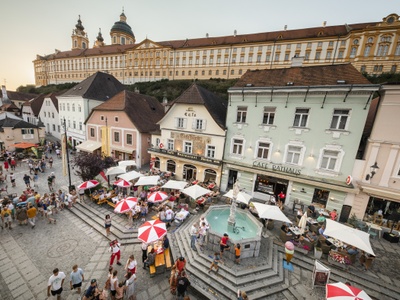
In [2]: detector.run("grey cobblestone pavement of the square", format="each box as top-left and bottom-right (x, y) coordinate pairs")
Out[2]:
(0, 156), (400, 300)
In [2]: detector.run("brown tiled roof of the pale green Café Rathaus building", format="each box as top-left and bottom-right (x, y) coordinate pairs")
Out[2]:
(234, 64), (371, 87)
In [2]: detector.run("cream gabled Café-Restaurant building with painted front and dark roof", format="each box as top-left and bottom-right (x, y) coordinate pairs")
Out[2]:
(149, 84), (227, 185)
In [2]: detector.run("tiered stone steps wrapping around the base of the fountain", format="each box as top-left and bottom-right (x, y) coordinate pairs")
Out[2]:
(173, 214), (288, 299)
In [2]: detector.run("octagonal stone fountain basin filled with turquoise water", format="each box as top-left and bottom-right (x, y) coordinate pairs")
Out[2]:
(205, 205), (263, 259)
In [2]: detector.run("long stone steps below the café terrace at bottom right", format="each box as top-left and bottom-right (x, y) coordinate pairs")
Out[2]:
(276, 242), (400, 299)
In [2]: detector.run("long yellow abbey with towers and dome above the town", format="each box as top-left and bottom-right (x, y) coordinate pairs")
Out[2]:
(33, 13), (400, 86)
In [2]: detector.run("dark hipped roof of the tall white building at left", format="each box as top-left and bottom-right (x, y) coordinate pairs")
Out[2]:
(61, 72), (124, 101)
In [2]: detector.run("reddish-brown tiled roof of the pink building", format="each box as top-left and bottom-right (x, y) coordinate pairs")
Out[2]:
(92, 91), (164, 132)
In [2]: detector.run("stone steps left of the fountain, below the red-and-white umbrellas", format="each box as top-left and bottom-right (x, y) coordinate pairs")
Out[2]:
(69, 203), (141, 244)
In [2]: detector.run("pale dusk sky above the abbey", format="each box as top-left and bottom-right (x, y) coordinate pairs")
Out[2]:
(0, 0), (400, 90)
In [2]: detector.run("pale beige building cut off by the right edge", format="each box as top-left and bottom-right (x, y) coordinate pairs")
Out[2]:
(352, 85), (400, 219)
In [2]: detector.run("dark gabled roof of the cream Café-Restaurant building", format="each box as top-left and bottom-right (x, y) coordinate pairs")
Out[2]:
(171, 83), (228, 128)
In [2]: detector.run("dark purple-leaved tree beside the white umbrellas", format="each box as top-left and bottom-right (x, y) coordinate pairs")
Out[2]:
(73, 152), (115, 181)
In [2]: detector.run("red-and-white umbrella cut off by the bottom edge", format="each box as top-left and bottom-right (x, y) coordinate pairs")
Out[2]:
(326, 282), (371, 300)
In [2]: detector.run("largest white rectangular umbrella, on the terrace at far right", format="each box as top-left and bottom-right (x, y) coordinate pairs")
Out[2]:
(324, 219), (375, 255)
